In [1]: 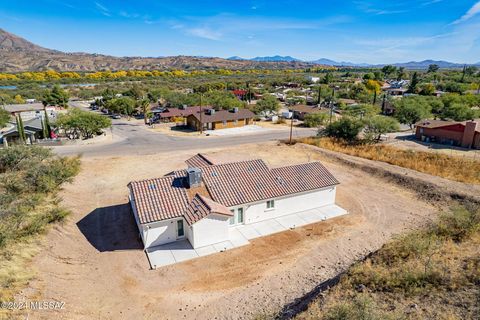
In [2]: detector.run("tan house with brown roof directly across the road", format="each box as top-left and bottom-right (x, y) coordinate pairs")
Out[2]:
(187, 108), (255, 130)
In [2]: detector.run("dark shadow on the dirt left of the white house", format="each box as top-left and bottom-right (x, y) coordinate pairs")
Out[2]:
(77, 203), (143, 252)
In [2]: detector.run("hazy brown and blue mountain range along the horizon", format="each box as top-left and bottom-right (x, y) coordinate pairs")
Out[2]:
(0, 29), (480, 72)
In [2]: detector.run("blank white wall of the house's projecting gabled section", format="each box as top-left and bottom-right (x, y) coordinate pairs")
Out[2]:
(189, 214), (229, 248)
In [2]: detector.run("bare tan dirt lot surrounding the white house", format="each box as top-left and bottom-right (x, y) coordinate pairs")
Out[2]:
(18, 142), (435, 319)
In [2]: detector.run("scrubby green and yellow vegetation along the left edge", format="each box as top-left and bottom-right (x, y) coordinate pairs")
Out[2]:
(0, 146), (80, 308)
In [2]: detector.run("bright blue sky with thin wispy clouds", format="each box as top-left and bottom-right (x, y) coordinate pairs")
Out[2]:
(0, 0), (480, 63)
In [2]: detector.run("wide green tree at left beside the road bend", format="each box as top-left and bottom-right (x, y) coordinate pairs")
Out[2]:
(56, 108), (112, 139)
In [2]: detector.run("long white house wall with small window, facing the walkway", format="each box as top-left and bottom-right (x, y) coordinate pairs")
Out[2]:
(243, 186), (336, 224)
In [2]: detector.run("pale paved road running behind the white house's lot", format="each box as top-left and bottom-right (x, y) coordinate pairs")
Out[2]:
(53, 115), (316, 156)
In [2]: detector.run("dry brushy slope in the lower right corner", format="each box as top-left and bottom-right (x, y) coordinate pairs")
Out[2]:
(296, 207), (480, 320)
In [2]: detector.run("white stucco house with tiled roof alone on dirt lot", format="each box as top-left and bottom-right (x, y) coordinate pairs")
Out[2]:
(128, 154), (339, 249)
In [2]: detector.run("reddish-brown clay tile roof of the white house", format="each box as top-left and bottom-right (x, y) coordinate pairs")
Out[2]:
(129, 160), (339, 224)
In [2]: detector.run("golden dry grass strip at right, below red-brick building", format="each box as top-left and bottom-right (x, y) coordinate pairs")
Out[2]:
(298, 138), (480, 184)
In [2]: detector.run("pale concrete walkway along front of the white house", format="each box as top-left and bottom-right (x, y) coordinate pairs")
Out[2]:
(146, 205), (347, 269)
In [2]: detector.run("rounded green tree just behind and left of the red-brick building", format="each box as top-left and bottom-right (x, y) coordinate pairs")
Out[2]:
(394, 97), (431, 128)
